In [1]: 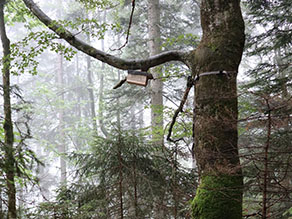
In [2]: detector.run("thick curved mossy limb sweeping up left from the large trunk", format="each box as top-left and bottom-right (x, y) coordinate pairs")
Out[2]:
(23, 0), (190, 70)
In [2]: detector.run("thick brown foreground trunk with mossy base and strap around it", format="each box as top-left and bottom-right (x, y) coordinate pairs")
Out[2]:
(192, 0), (245, 219)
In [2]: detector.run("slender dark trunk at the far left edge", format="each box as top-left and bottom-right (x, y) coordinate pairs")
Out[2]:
(0, 0), (17, 219)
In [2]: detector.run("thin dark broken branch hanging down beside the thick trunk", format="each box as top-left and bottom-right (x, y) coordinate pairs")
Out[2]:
(166, 77), (194, 143)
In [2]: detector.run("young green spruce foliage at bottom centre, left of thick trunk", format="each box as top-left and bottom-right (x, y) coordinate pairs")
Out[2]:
(32, 131), (195, 218)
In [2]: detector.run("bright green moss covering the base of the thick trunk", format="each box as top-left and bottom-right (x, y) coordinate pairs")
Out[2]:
(191, 175), (242, 219)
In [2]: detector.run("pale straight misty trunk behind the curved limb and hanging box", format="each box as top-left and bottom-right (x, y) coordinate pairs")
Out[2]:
(148, 0), (163, 145)
